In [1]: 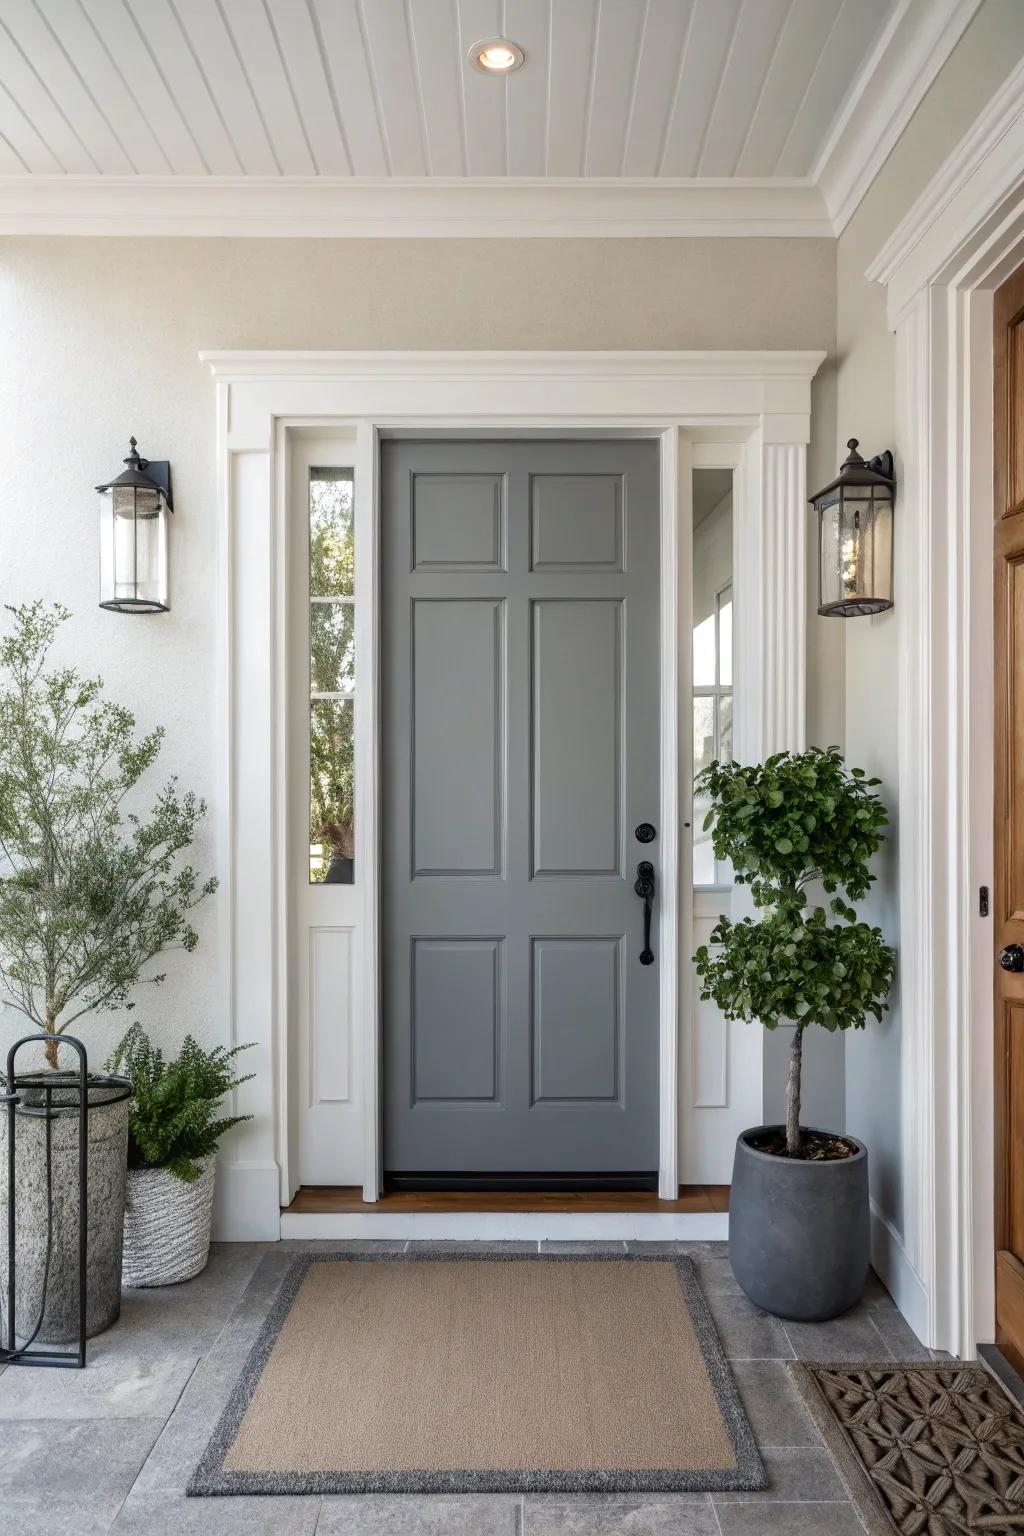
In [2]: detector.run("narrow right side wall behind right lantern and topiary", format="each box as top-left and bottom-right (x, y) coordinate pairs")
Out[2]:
(837, 0), (1024, 1230)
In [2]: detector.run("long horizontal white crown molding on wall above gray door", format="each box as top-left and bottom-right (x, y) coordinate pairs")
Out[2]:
(0, 175), (834, 240)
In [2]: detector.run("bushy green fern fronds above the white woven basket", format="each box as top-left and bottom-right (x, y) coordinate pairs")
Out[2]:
(107, 1025), (253, 1184)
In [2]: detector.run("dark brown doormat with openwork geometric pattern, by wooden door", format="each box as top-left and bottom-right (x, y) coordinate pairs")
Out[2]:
(789, 1362), (1024, 1536)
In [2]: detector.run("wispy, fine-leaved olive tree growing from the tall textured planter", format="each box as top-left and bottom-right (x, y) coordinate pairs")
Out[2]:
(0, 602), (216, 1068)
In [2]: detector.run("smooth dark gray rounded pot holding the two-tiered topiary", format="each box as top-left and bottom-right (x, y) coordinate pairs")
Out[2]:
(729, 1126), (870, 1322)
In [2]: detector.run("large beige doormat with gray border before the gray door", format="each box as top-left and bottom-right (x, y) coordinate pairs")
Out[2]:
(187, 1250), (766, 1495)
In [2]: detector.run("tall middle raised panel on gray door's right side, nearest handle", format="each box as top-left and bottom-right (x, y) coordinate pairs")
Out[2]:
(531, 599), (623, 877)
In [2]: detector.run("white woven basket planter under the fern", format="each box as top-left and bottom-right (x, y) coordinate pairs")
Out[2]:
(123, 1154), (216, 1286)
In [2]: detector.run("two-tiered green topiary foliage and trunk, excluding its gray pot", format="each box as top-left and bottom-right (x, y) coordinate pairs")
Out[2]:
(694, 746), (895, 1157)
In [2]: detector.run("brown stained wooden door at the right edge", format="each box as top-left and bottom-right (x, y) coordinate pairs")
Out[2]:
(993, 258), (1024, 1372)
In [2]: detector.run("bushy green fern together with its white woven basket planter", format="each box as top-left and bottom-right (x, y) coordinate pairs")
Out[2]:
(107, 1025), (252, 1286)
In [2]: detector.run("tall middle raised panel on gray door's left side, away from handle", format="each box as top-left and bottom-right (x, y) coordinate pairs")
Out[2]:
(411, 598), (505, 879)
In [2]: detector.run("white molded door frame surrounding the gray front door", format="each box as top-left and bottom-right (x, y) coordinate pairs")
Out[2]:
(201, 352), (824, 1238)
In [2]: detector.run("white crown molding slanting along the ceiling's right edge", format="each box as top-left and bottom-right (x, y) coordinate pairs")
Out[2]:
(811, 0), (981, 237)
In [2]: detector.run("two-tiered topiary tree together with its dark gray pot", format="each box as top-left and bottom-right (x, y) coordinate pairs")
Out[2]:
(694, 746), (895, 1321)
